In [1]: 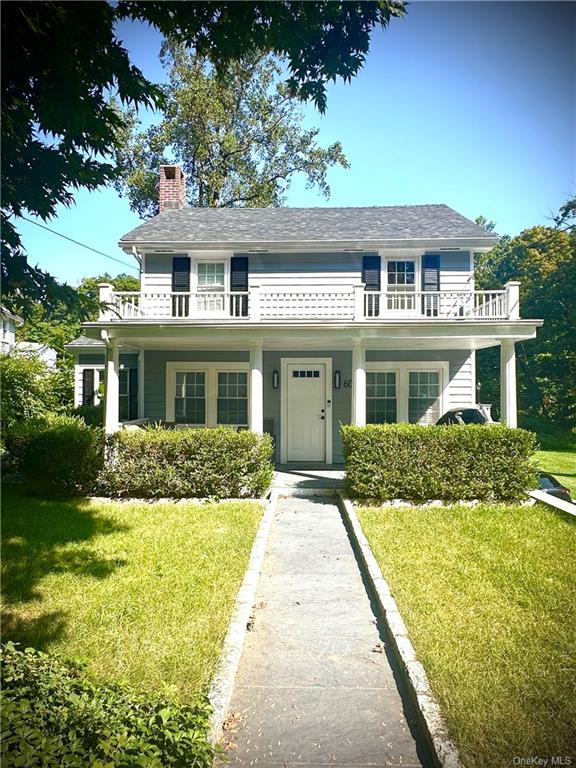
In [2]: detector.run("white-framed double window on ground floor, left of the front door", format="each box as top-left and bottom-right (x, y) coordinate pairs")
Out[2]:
(166, 362), (248, 427)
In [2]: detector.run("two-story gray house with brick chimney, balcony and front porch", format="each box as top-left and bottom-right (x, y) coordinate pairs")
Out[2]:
(69, 166), (541, 463)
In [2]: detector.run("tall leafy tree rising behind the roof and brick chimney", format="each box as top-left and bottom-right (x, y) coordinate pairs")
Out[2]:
(112, 43), (348, 218)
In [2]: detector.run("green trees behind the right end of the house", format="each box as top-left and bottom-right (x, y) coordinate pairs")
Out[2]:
(476, 219), (576, 429)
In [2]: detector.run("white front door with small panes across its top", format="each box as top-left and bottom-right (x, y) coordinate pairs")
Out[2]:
(285, 362), (327, 461)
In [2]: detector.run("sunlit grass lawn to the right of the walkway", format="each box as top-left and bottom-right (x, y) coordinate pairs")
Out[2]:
(359, 505), (576, 768)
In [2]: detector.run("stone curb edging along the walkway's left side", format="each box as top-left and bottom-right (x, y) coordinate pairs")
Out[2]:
(208, 490), (278, 744)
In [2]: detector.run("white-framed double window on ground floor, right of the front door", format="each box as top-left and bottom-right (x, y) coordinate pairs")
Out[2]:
(366, 362), (449, 424)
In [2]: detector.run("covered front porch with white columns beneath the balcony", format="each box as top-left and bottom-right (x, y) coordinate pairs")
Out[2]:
(83, 320), (538, 465)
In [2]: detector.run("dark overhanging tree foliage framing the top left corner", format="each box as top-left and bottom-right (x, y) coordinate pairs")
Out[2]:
(1, 0), (405, 311)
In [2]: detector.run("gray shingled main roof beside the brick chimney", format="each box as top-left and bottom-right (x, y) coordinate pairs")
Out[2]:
(120, 205), (495, 245)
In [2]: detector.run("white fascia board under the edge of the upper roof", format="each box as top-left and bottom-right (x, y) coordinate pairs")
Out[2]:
(118, 237), (498, 253)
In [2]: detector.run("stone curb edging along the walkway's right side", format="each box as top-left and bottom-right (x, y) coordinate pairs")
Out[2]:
(338, 493), (464, 768)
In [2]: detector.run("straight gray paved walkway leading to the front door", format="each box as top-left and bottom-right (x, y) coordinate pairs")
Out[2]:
(225, 496), (430, 768)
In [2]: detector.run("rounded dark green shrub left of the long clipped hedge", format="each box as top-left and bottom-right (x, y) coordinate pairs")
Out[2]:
(6, 416), (104, 496)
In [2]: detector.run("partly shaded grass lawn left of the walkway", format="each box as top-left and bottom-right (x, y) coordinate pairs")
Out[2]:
(2, 491), (262, 696)
